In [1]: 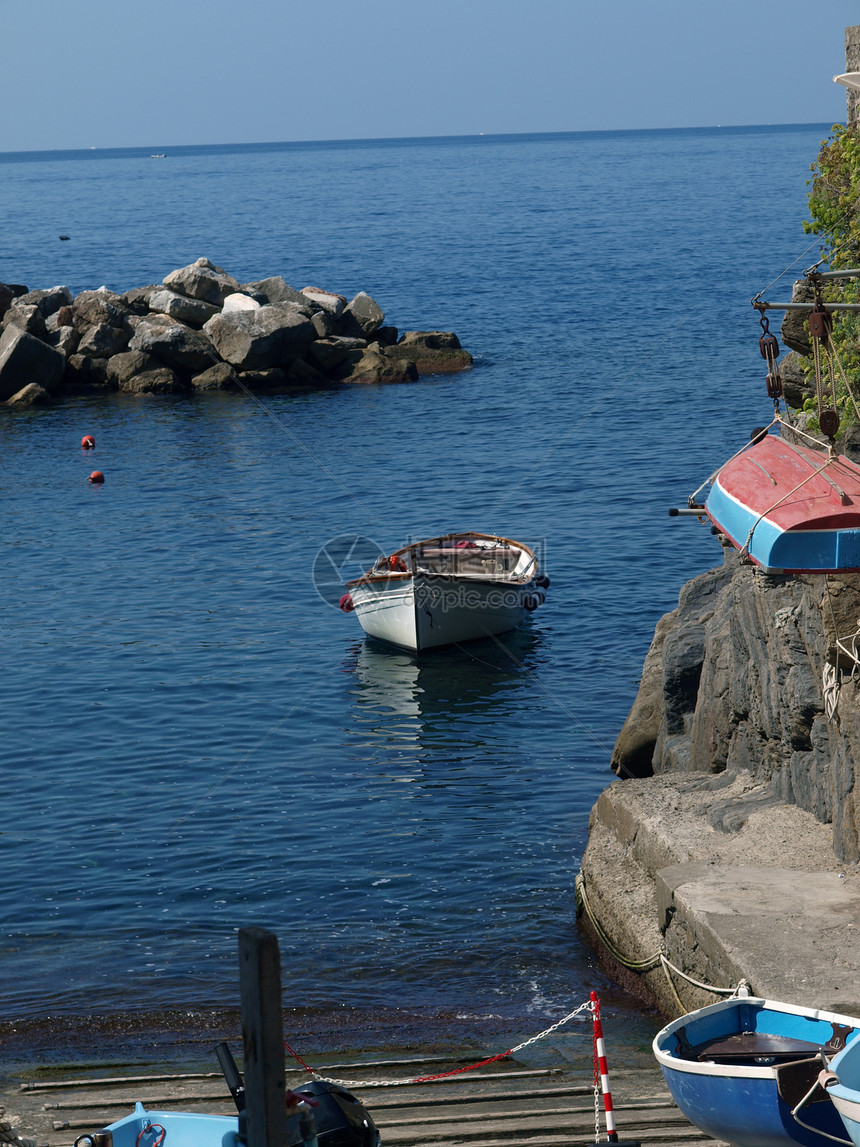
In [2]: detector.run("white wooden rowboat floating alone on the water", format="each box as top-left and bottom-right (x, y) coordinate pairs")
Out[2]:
(347, 533), (546, 653)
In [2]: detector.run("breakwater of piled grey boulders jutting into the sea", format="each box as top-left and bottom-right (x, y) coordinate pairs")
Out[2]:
(0, 259), (472, 406)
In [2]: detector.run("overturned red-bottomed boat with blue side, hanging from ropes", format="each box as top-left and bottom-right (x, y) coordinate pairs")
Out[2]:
(705, 435), (860, 574)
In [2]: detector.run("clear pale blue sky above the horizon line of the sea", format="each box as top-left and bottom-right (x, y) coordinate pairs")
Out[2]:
(0, 0), (860, 151)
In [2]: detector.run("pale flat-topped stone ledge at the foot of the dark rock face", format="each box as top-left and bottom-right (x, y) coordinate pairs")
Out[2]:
(580, 773), (860, 1015)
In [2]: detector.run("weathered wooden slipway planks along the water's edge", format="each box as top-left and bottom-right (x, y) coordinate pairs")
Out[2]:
(3, 1053), (718, 1147)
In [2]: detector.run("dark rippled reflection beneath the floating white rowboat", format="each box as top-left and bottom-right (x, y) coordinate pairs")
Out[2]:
(345, 629), (541, 752)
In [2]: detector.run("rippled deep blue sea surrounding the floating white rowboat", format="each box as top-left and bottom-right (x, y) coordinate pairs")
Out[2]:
(0, 124), (829, 1054)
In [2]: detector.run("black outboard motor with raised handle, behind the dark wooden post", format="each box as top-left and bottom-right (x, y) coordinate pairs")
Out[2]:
(216, 1044), (382, 1147)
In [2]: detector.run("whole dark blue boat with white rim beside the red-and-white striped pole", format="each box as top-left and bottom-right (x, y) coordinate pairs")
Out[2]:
(654, 996), (860, 1147)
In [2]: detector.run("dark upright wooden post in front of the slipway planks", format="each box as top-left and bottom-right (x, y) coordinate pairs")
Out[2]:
(239, 928), (287, 1147)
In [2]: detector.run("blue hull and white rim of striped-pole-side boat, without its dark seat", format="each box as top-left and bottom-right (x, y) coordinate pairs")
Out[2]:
(654, 998), (860, 1147)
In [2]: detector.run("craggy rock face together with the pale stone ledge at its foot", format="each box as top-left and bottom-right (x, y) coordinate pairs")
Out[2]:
(577, 549), (860, 1016)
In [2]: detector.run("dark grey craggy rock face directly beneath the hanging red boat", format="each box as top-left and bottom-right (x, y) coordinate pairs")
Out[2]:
(612, 551), (860, 861)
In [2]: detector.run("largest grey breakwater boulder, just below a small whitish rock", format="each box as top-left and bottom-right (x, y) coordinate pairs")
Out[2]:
(203, 303), (316, 370)
